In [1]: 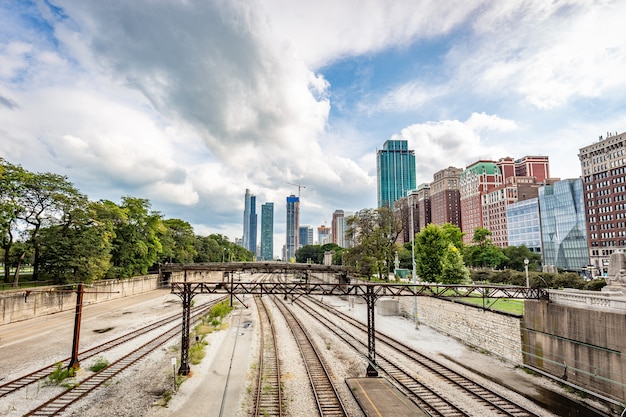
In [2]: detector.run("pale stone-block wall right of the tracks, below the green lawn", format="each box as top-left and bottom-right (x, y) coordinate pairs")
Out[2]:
(398, 297), (523, 364)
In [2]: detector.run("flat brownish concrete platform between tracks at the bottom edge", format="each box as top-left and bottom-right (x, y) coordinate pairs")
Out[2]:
(346, 377), (428, 417)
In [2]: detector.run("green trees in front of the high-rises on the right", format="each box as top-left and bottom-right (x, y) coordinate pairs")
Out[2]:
(296, 207), (541, 284)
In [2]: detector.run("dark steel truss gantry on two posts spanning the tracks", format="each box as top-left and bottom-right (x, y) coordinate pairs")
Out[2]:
(171, 281), (548, 376)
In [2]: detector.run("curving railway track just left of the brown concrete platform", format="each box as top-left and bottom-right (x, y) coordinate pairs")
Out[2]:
(272, 297), (348, 417)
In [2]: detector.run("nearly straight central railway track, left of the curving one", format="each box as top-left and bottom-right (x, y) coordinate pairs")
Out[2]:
(253, 296), (283, 417)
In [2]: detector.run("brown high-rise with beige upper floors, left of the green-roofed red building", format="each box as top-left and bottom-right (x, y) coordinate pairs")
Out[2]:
(429, 167), (463, 227)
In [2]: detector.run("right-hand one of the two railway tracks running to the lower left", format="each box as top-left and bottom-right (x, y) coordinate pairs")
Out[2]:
(19, 299), (222, 416)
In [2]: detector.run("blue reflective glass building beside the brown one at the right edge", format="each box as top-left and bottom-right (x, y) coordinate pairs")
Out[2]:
(539, 178), (589, 271)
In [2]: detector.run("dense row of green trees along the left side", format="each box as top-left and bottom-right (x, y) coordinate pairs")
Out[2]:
(0, 158), (253, 285)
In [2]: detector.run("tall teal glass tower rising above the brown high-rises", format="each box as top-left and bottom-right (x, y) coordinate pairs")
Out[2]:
(376, 140), (416, 208)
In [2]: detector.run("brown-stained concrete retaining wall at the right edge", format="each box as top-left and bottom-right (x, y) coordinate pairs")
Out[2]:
(522, 298), (626, 402)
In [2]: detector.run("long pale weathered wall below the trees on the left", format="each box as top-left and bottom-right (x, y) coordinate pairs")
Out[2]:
(0, 274), (160, 324)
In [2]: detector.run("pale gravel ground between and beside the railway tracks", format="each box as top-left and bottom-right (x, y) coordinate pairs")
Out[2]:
(0, 291), (604, 417)
